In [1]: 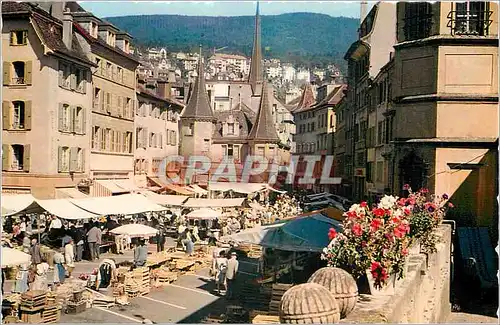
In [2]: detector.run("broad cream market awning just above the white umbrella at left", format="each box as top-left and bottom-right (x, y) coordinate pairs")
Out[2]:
(70, 194), (166, 215)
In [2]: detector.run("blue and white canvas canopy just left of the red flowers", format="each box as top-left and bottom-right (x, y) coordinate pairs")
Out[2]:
(221, 213), (341, 252)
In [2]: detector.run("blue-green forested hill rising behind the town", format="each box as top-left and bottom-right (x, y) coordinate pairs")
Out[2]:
(105, 13), (359, 71)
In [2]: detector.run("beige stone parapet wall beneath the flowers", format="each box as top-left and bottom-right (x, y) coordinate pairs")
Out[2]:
(341, 225), (451, 323)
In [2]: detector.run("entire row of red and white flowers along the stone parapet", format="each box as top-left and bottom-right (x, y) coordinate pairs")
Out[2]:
(322, 186), (451, 288)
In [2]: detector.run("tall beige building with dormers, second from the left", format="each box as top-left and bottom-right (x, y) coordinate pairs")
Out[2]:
(73, 8), (139, 196)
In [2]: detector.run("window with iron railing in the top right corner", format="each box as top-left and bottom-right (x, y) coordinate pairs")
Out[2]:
(448, 1), (492, 36)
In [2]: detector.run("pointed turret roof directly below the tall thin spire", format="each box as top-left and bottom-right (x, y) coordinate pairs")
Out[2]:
(248, 81), (280, 143)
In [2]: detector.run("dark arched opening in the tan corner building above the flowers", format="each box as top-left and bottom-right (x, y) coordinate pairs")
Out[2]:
(399, 152), (427, 191)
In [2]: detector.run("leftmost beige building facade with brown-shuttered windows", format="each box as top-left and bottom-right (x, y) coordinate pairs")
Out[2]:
(2, 2), (95, 199)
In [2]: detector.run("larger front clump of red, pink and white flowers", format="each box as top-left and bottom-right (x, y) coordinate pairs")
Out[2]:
(322, 196), (411, 294)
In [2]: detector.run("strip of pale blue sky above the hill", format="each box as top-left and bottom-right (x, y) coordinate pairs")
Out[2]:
(78, 0), (374, 18)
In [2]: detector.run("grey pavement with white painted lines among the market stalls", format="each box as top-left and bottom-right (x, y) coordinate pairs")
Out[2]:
(5, 238), (256, 323)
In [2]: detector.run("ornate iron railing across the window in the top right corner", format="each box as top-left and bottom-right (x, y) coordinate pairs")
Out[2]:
(447, 10), (493, 36)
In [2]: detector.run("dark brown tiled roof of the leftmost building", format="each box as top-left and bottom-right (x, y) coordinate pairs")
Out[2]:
(2, 1), (95, 66)
